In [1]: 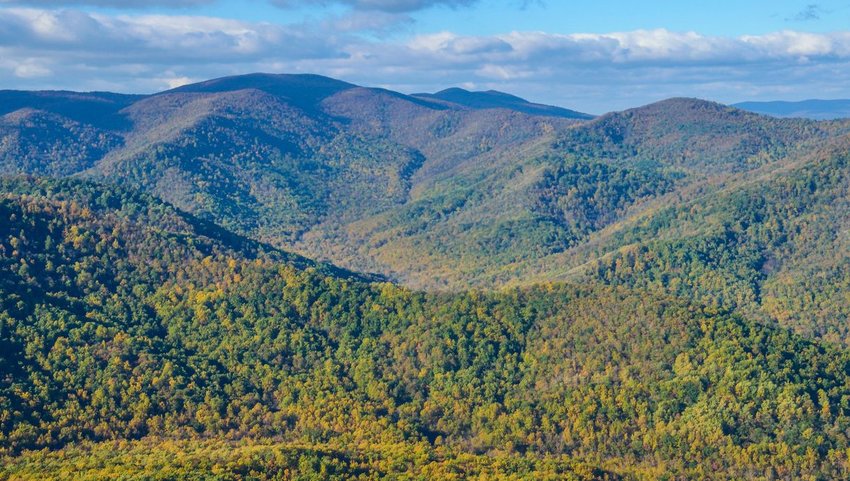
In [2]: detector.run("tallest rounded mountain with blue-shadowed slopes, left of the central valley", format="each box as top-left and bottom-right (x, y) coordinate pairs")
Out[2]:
(4, 74), (588, 283)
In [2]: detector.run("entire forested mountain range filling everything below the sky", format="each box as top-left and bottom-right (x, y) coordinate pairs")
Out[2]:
(0, 74), (850, 479)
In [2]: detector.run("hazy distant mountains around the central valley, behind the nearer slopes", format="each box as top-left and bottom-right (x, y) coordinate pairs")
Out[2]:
(0, 74), (850, 291)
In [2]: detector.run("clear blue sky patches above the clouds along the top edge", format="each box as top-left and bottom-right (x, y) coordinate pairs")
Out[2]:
(86, 0), (850, 35)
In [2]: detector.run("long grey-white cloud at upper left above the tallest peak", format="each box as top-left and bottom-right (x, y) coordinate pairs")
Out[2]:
(0, 9), (346, 63)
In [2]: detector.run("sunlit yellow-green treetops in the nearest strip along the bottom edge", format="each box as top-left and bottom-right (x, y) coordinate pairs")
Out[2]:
(0, 439), (620, 481)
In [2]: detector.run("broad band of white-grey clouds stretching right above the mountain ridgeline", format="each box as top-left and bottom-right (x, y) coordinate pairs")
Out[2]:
(0, 6), (850, 112)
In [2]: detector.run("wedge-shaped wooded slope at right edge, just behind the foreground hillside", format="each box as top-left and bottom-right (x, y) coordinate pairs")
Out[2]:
(588, 142), (850, 344)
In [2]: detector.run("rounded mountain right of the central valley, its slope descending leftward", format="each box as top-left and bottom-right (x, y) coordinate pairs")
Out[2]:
(305, 99), (848, 288)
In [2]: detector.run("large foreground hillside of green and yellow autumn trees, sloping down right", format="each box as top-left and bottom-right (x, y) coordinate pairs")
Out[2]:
(0, 179), (850, 479)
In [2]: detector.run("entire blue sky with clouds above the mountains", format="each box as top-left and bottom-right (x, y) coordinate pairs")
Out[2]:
(0, 0), (850, 114)
